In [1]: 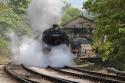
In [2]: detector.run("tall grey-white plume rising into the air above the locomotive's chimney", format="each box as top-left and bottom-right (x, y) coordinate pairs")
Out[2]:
(27, 0), (65, 32)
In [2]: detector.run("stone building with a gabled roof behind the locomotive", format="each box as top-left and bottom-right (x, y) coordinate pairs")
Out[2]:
(63, 16), (94, 40)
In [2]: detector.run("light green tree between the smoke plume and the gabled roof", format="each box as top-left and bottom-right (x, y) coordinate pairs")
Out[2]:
(61, 4), (82, 25)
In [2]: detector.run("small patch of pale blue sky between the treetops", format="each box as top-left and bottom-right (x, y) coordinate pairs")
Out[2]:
(68, 0), (86, 9)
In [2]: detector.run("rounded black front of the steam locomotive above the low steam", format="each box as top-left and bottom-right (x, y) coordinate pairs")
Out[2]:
(42, 24), (69, 46)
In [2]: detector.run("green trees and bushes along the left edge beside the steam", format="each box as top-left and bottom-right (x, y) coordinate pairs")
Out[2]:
(0, 0), (31, 62)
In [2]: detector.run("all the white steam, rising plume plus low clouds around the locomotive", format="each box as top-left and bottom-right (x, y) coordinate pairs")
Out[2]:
(9, 0), (73, 67)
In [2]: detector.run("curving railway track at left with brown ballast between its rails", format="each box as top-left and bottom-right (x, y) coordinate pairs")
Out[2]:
(4, 63), (77, 83)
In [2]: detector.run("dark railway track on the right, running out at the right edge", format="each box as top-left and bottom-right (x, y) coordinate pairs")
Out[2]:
(49, 67), (125, 83)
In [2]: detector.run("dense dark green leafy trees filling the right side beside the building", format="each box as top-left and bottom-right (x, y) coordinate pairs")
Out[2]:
(84, 0), (125, 63)
